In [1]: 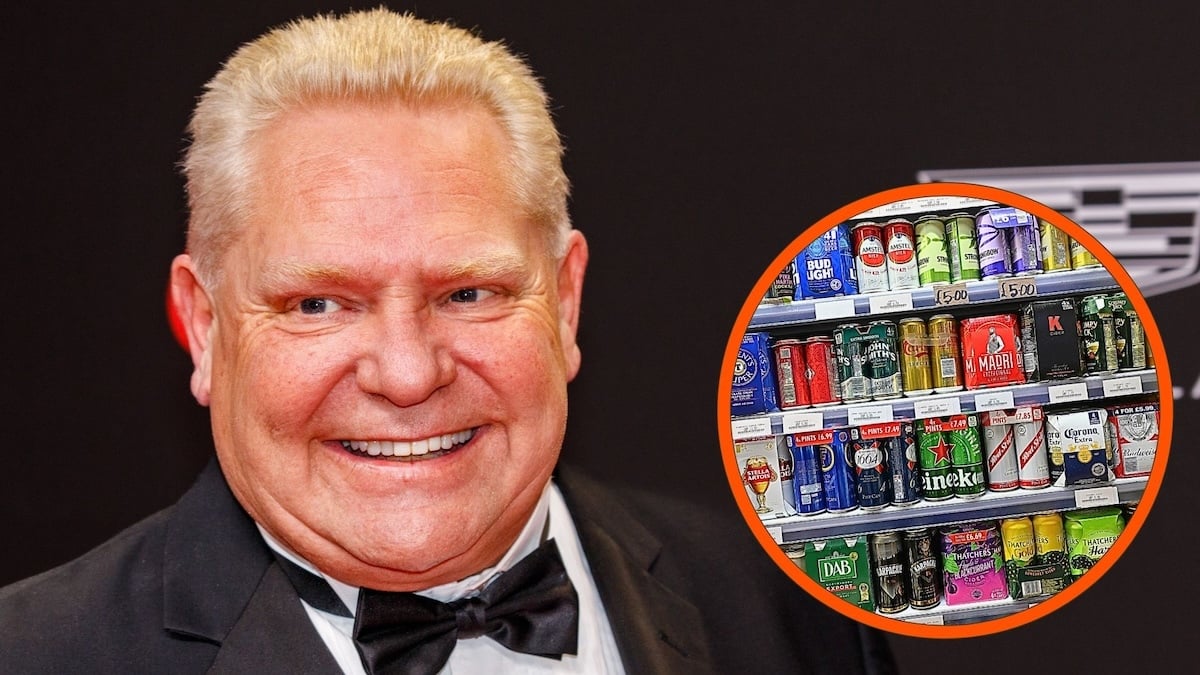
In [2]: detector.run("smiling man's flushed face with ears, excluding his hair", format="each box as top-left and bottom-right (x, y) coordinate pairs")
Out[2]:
(173, 104), (587, 590)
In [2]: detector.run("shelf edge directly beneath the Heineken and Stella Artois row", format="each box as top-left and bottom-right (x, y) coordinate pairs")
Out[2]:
(762, 477), (1148, 544)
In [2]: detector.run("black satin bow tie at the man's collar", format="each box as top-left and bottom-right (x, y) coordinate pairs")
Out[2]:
(276, 539), (580, 675)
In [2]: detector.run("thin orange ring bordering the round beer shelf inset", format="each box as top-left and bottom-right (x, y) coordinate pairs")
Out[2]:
(716, 183), (1175, 639)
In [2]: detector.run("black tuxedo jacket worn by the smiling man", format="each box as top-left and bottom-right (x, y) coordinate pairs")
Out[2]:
(0, 461), (893, 675)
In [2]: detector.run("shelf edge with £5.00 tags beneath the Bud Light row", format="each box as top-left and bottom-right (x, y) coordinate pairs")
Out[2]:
(749, 268), (1120, 330)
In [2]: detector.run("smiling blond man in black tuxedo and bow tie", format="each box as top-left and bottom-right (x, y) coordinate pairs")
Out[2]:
(0, 10), (890, 673)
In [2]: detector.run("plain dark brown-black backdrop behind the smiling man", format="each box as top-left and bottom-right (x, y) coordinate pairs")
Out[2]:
(0, 0), (1200, 673)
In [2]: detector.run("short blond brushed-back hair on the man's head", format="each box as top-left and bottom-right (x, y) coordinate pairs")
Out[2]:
(182, 8), (570, 281)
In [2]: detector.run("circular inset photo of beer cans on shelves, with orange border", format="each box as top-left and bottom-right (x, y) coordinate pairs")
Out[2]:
(716, 183), (1174, 638)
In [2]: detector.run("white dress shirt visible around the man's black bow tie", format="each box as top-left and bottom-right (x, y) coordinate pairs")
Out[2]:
(258, 483), (625, 675)
